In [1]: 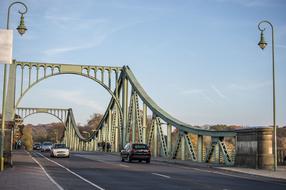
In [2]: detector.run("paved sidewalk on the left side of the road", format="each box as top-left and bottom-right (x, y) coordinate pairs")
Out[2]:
(0, 150), (57, 190)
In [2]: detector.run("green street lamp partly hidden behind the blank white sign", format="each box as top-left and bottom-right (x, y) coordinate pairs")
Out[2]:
(0, 1), (28, 171)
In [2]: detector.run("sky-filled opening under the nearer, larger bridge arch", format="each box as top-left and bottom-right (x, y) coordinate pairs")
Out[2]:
(16, 74), (115, 128)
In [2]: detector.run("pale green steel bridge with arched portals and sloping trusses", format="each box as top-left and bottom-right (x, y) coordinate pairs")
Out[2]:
(5, 60), (236, 165)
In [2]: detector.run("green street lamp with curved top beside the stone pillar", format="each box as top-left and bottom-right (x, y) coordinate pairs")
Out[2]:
(258, 20), (277, 171)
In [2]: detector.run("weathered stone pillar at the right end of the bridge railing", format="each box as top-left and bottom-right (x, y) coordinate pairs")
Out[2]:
(235, 128), (274, 169)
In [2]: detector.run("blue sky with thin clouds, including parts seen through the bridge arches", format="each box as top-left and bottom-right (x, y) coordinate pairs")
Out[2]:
(0, 0), (286, 126)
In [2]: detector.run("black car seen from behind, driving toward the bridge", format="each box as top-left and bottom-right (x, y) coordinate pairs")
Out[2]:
(120, 143), (151, 163)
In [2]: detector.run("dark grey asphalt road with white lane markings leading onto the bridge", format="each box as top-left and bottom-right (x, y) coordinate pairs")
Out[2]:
(32, 152), (286, 190)
